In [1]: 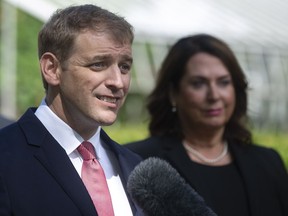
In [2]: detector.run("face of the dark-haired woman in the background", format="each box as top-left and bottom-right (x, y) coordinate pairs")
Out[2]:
(172, 53), (235, 130)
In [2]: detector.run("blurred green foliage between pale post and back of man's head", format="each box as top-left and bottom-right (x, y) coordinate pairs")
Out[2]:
(0, 0), (44, 116)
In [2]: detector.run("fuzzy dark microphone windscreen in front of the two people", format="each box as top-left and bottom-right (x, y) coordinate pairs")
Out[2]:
(127, 157), (217, 216)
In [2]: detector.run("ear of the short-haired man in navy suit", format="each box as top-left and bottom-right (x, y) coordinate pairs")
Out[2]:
(40, 52), (61, 86)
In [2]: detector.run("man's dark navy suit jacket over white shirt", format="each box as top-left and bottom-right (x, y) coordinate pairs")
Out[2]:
(0, 109), (141, 216)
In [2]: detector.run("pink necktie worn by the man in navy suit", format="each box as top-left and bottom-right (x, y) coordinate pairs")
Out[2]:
(77, 141), (114, 216)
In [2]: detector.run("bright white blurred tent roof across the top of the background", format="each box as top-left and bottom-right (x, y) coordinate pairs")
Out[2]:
(4, 0), (288, 46)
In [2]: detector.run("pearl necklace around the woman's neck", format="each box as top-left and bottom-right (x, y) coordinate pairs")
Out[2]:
(183, 141), (228, 164)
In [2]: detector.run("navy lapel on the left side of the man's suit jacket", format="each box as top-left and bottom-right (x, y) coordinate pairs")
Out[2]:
(19, 110), (97, 216)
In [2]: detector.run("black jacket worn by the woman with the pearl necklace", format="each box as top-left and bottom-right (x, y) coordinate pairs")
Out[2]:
(125, 137), (288, 216)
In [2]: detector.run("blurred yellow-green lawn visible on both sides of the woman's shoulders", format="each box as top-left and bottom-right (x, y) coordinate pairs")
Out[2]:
(104, 123), (288, 169)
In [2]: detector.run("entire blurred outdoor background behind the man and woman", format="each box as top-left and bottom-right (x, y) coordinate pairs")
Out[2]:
(0, 0), (288, 165)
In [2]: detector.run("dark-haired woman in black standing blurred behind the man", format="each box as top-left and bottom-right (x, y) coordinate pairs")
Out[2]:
(126, 34), (288, 216)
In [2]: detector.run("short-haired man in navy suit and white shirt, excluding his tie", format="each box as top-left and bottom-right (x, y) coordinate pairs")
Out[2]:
(0, 5), (141, 216)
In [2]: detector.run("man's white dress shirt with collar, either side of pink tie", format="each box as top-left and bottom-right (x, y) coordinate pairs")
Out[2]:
(35, 99), (133, 216)
